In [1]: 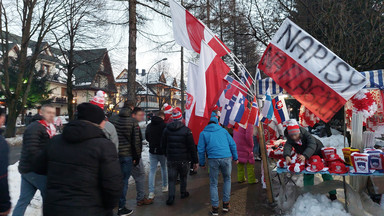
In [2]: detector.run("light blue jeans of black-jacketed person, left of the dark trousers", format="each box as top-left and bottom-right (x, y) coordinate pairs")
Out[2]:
(148, 153), (168, 193)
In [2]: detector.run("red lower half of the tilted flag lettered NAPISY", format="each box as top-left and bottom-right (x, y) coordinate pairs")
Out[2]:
(259, 44), (346, 122)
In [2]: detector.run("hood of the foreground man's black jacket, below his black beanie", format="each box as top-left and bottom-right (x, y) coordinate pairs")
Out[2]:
(63, 120), (105, 143)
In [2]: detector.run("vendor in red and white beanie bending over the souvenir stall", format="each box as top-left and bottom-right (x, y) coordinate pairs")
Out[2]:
(283, 120), (337, 200)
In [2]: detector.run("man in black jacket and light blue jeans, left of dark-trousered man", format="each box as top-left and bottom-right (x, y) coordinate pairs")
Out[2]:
(145, 111), (168, 199)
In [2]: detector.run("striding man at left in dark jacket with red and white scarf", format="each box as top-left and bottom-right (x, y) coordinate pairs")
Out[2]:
(13, 105), (56, 216)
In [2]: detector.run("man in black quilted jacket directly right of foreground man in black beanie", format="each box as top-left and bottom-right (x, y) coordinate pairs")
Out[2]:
(111, 106), (142, 216)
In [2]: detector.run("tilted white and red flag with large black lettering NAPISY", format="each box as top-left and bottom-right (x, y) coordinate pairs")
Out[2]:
(258, 19), (367, 122)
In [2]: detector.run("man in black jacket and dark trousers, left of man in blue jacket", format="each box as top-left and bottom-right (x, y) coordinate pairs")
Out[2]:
(162, 109), (199, 205)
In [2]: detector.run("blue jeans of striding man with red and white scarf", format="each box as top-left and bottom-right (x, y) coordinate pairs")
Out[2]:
(13, 172), (47, 216)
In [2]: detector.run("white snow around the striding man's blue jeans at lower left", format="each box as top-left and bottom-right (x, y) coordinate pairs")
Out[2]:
(8, 162), (43, 216)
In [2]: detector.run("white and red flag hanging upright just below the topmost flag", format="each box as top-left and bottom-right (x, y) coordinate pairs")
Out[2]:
(195, 41), (231, 119)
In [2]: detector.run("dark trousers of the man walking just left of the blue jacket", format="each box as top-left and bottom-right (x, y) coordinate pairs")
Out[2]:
(167, 161), (189, 197)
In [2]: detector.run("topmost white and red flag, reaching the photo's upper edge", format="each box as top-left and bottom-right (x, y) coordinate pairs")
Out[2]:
(169, 0), (230, 57)
